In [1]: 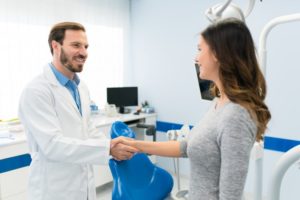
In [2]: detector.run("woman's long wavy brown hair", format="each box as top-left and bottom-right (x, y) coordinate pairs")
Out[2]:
(201, 19), (271, 141)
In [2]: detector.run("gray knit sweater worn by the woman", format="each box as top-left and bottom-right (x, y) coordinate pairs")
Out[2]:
(180, 99), (257, 200)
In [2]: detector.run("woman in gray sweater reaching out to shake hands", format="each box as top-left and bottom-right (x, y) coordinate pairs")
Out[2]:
(116, 19), (271, 200)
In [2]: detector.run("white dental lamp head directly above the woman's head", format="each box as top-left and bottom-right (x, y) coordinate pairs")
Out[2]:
(205, 0), (255, 23)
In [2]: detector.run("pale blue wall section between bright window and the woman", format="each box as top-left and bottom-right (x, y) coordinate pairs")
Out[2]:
(131, 0), (211, 124)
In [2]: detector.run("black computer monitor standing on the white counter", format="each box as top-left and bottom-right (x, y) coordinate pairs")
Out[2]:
(106, 87), (138, 113)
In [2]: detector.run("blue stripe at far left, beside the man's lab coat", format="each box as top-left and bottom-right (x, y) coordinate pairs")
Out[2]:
(0, 154), (31, 173)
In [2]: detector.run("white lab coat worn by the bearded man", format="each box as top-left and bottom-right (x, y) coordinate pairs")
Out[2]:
(19, 65), (110, 200)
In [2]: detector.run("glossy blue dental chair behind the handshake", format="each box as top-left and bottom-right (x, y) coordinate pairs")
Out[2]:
(109, 121), (173, 200)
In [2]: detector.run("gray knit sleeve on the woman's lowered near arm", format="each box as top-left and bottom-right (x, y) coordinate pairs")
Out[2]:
(218, 108), (256, 200)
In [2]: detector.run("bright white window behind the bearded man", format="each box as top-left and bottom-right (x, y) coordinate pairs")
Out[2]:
(0, 0), (130, 119)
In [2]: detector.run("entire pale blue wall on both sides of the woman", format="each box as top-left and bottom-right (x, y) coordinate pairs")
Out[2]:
(131, 0), (300, 200)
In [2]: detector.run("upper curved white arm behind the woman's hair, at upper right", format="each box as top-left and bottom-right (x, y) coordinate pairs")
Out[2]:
(258, 13), (300, 75)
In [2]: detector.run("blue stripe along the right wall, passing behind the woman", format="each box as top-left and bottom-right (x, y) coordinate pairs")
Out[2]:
(156, 121), (300, 152)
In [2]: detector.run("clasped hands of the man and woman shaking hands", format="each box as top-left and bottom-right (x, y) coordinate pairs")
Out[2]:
(110, 136), (139, 161)
